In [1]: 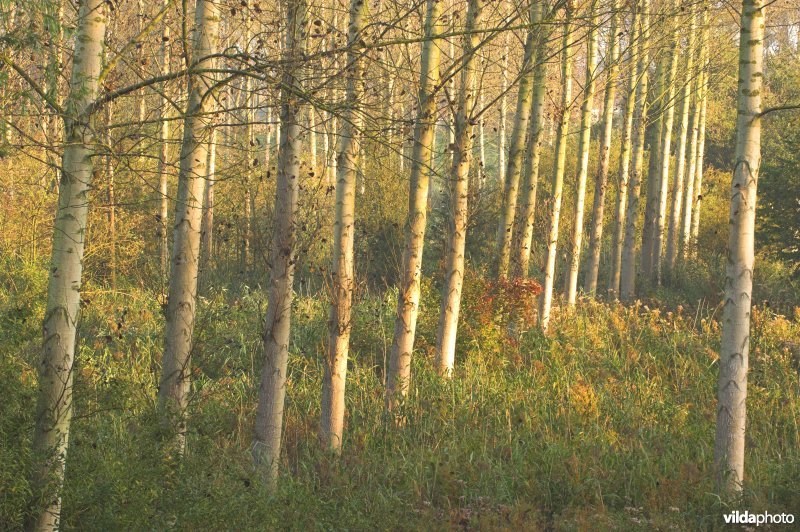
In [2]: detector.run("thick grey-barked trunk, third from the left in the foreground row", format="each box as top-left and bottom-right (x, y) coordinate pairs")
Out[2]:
(253, 0), (308, 484)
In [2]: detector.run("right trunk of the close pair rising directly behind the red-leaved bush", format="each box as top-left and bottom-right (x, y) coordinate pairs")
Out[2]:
(512, 2), (549, 278)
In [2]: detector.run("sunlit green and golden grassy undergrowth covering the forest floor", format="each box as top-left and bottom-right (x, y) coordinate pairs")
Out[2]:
(0, 264), (800, 530)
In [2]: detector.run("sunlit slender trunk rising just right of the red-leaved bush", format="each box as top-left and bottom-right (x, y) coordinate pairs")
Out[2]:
(539, 6), (575, 331)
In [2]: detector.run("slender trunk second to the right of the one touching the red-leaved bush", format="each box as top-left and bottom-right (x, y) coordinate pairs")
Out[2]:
(583, 0), (620, 295)
